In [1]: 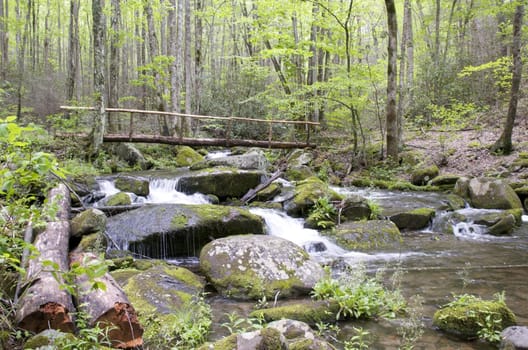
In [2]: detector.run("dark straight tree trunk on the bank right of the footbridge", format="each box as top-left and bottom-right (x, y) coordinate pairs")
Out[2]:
(385, 0), (399, 161)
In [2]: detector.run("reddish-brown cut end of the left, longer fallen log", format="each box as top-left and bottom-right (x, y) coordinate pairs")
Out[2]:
(19, 302), (74, 334)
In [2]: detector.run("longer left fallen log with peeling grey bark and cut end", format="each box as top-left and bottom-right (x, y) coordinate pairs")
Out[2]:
(15, 185), (74, 333)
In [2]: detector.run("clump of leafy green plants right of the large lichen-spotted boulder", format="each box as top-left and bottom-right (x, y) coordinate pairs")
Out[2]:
(312, 267), (406, 319)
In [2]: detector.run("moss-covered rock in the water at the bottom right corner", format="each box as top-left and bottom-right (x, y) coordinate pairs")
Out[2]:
(433, 296), (516, 339)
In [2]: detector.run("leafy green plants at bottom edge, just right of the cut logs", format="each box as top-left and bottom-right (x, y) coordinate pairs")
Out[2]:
(143, 296), (212, 350)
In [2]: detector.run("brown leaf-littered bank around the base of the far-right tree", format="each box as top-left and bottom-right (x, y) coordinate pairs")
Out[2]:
(405, 115), (528, 181)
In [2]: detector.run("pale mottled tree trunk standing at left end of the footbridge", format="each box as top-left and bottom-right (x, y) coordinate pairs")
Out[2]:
(92, 0), (106, 154)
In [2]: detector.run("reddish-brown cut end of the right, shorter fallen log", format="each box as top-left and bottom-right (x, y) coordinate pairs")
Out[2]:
(96, 302), (143, 349)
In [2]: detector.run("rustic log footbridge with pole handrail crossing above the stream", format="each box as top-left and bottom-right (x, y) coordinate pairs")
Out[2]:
(56, 106), (320, 149)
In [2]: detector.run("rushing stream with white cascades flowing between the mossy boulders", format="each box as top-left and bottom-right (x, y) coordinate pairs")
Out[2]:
(99, 175), (528, 350)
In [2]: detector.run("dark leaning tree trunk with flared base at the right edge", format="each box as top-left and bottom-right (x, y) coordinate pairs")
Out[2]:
(491, 3), (524, 154)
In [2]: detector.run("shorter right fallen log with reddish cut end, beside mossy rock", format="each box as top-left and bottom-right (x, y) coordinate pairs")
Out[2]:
(70, 253), (143, 349)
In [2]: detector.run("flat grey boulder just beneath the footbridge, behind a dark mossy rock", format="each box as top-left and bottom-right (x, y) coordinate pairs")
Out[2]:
(191, 149), (269, 171)
